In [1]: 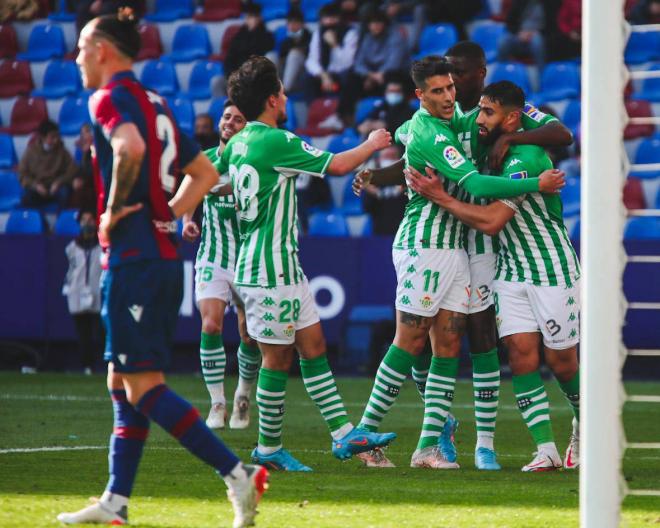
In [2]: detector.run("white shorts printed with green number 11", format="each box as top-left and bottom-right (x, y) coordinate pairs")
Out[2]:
(392, 245), (470, 317)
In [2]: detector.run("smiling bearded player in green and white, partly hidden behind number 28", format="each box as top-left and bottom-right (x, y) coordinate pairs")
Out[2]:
(183, 99), (261, 429)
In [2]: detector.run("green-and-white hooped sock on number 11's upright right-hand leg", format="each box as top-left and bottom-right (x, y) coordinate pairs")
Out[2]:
(417, 357), (458, 449)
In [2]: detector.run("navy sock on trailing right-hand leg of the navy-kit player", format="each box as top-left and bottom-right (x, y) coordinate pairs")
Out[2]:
(136, 385), (240, 477)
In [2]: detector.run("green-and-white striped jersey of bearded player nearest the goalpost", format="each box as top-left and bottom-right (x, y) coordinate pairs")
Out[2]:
(495, 145), (580, 286)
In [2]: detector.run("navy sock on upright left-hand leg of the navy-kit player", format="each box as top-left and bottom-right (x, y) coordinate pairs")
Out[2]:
(105, 390), (149, 497)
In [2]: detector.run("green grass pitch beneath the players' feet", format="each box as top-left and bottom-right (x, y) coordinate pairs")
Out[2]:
(0, 373), (660, 528)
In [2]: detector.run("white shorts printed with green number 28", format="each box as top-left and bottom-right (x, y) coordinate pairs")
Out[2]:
(237, 279), (320, 345)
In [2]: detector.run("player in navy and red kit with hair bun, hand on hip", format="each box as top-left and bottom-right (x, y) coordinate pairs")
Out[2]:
(58, 10), (268, 528)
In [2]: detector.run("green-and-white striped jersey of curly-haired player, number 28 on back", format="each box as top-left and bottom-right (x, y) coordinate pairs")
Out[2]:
(220, 121), (332, 287)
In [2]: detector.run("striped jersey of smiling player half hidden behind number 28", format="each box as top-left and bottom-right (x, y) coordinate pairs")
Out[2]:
(196, 147), (240, 272)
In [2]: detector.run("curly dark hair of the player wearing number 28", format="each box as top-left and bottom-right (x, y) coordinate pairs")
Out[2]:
(227, 55), (282, 121)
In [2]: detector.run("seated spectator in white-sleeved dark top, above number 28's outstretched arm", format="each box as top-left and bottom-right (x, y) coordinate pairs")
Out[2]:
(305, 4), (358, 100)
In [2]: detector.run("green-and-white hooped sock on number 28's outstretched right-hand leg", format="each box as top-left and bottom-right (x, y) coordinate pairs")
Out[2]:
(300, 354), (352, 439)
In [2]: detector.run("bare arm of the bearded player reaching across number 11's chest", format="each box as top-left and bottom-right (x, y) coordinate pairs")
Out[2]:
(405, 167), (515, 235)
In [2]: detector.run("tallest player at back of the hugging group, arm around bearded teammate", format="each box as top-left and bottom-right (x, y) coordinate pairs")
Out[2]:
(354, 41), (572, 470)
